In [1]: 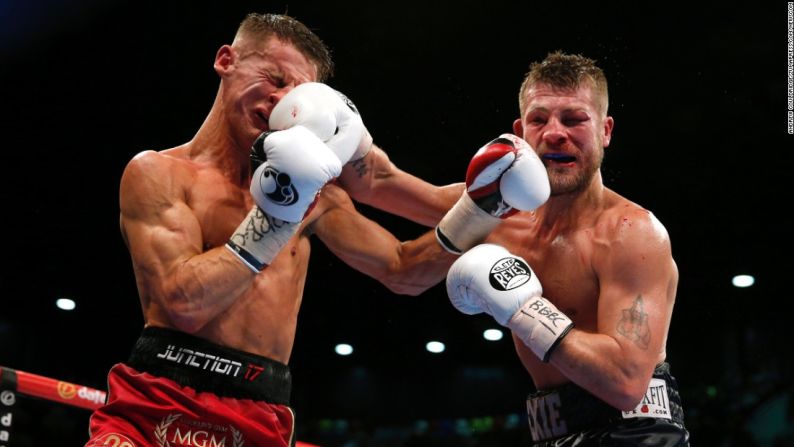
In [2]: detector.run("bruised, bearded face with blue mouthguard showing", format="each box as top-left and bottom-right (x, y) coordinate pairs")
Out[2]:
(513, 83), (614, 196)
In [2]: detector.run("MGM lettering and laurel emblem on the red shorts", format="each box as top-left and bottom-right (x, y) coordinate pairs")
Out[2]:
(154, 413), (245, 447)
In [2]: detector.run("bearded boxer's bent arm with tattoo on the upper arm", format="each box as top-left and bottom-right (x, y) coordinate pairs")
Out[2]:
(550, 210), (678, 410)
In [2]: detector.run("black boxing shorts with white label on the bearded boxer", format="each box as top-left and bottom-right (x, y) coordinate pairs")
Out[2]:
(527, 363), (689, 447)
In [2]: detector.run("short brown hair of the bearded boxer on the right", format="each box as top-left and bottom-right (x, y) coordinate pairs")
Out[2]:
(518, 51), (609, 116)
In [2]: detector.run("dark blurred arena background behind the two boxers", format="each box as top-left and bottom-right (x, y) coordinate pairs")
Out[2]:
(0, 0), (794, 447)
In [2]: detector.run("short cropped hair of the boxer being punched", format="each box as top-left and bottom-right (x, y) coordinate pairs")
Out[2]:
(234, 13), (334, 82)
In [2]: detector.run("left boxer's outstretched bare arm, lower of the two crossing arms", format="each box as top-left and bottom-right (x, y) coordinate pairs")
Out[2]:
(311, 185), (457, 295)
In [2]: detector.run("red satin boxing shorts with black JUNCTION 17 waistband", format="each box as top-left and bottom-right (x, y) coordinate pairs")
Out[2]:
(86, 327), (295, 447)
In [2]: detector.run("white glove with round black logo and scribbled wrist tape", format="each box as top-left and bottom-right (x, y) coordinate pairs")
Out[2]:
(226, 126), (342, 272)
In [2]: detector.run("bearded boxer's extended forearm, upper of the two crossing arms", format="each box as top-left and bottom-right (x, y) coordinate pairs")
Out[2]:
(339, 145), (463, 227)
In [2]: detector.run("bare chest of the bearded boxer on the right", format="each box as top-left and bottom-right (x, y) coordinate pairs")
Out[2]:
(488, 220), (599, 327)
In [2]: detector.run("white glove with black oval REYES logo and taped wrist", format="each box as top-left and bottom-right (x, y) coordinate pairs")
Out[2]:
(447, 244), (573, 362)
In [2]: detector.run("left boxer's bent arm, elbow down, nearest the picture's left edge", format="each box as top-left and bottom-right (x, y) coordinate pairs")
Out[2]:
(120, 152), (254, 333)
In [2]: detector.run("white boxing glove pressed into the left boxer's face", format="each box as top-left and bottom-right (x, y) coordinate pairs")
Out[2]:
(268, 82), (372, 164)
